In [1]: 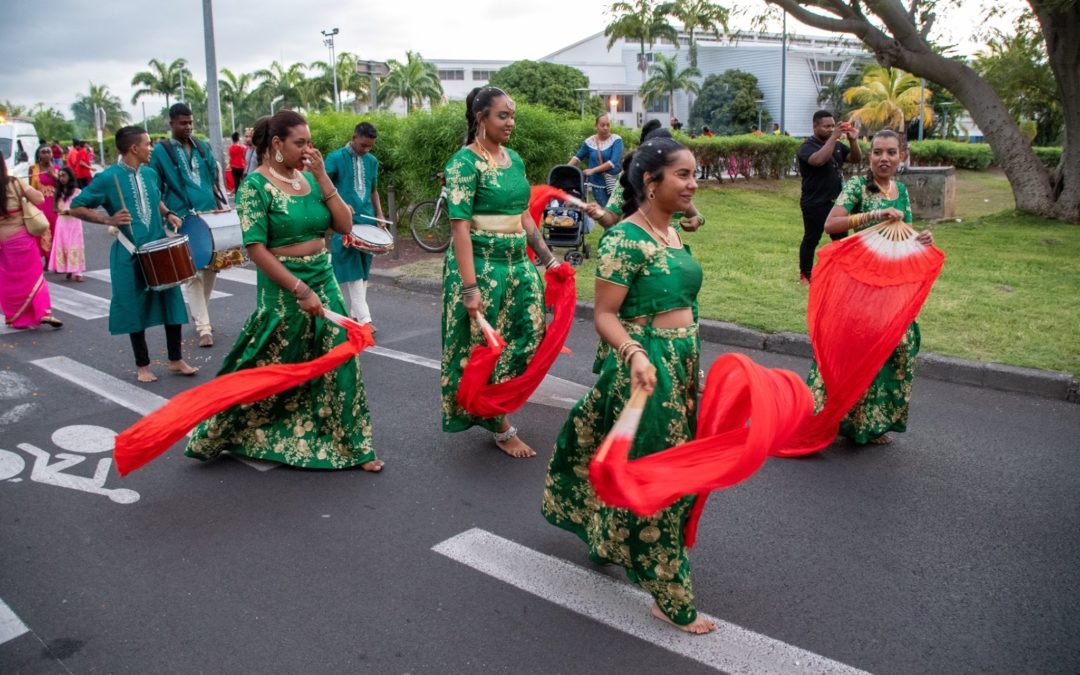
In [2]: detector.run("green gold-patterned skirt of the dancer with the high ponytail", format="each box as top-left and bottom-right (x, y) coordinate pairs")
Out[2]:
(440, 232), (546, 431)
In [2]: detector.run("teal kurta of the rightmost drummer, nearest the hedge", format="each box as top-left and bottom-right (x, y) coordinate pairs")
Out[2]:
(326, 145), (379, 282)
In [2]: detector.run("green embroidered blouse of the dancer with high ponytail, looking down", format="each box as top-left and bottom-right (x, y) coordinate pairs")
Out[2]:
(446, 148), (529, 220)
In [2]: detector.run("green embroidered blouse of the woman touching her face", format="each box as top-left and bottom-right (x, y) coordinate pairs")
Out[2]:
(237, 172), (330, 248)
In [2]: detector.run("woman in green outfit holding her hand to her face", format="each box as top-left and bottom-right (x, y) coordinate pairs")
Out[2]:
(186, 110), (382, 471)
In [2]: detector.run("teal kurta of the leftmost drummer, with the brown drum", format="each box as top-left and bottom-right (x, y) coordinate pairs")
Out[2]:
(71, 162), (188, 335)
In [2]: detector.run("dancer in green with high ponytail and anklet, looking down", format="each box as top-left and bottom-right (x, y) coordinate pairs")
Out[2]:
(441, 86), (559, 457)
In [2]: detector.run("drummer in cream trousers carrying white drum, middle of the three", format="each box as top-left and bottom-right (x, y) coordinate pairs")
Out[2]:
(150, 103), (229, 347)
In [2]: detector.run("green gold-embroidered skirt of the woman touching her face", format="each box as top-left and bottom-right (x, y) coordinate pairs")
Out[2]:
(186, 252), (375, 469)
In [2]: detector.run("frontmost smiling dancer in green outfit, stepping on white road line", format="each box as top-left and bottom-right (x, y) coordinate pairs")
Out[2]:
(542, 138), (716, 633)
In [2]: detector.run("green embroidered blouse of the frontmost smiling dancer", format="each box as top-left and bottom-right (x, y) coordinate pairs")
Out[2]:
(596, 220), (703, 319)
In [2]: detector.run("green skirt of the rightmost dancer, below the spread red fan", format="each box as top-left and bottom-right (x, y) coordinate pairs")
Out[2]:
(807, 321), (922, 444)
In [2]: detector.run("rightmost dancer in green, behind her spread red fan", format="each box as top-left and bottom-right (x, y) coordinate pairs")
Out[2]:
(807, 130), (934, 445)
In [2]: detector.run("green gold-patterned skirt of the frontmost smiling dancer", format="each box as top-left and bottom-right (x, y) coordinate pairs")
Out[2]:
(541, 323), (699, 625)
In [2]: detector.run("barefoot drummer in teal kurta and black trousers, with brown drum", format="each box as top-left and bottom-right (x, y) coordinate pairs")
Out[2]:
(71, 126), (199, 382)
